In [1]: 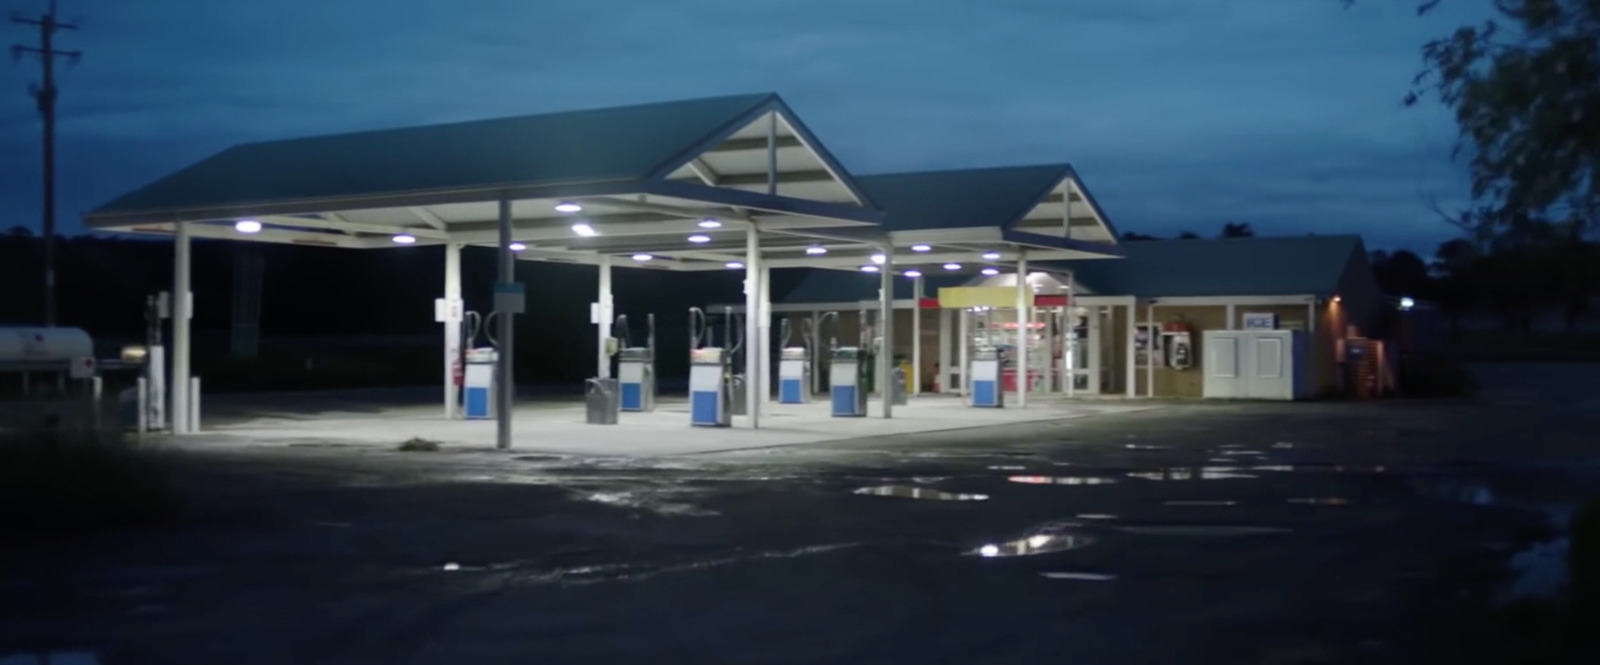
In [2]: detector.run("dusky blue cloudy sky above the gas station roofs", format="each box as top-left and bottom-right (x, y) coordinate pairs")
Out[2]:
(0, 0), (1485, 251)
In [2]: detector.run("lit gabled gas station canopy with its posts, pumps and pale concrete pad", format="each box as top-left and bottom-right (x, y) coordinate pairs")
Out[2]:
(75, 94), (1158, 452)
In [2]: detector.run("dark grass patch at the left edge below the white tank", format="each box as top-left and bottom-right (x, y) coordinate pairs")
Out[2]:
(0, 430), (182, 534)
